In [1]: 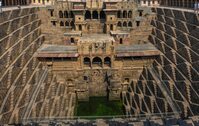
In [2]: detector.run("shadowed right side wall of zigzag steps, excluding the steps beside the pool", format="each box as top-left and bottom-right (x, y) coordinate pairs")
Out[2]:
(149, 8), (199, 116)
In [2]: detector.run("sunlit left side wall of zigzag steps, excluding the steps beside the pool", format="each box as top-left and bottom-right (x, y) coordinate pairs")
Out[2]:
(0, 8), (44, 123)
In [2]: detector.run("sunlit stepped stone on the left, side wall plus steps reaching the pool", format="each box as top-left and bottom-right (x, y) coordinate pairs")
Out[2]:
(0, 8), (74, 124)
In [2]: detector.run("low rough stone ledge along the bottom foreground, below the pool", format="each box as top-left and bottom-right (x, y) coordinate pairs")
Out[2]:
(23, 117), (199, 126)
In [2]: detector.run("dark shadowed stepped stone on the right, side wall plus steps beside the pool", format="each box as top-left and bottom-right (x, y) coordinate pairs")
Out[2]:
(124, 8), (199, 116)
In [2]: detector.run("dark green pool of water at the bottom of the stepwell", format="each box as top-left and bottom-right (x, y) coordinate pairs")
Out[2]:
(76, 97), (123, 116)
